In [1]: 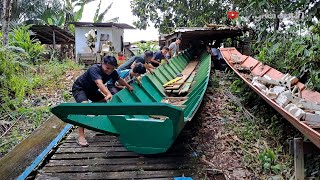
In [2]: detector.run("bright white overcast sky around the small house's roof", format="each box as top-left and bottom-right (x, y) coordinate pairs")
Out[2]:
(81, 0), (159, 42)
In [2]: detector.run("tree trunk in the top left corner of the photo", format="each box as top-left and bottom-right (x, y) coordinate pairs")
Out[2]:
(1, 0), (12, 46)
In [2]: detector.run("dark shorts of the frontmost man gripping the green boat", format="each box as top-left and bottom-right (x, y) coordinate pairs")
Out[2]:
(72, 83), (104, 103)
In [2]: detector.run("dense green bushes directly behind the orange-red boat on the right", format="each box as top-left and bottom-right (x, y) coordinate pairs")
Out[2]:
(252, 28), (320, 91)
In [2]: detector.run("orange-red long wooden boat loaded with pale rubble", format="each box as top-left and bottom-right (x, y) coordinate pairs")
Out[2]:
(221, 48), (320, 148)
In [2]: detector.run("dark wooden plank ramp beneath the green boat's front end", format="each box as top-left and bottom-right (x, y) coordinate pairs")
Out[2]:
(35, 130), (196, 180)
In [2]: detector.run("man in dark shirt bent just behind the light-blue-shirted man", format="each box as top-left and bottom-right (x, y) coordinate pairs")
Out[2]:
(118, 50), (153, 71)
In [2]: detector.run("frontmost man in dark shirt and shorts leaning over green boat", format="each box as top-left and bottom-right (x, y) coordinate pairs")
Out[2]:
(72, 56), (133, 146)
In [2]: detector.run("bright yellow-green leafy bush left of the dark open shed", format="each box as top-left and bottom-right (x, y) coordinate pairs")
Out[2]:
(9, 25), (45, 63)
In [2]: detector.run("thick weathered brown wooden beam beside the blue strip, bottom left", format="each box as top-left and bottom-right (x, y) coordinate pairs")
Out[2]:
(0, 116), (66, 179)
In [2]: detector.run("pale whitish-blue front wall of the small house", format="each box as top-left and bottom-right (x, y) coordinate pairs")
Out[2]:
(75, 27), (124, 59)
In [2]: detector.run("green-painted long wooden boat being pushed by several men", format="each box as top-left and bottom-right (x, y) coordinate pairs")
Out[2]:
(51, 50), (211, 154)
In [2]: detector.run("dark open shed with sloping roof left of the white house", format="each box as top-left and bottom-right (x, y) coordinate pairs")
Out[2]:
(30, 25), (74, 44)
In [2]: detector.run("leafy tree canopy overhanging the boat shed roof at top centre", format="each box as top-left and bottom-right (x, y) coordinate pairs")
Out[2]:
(131, 0), (230, 33)
